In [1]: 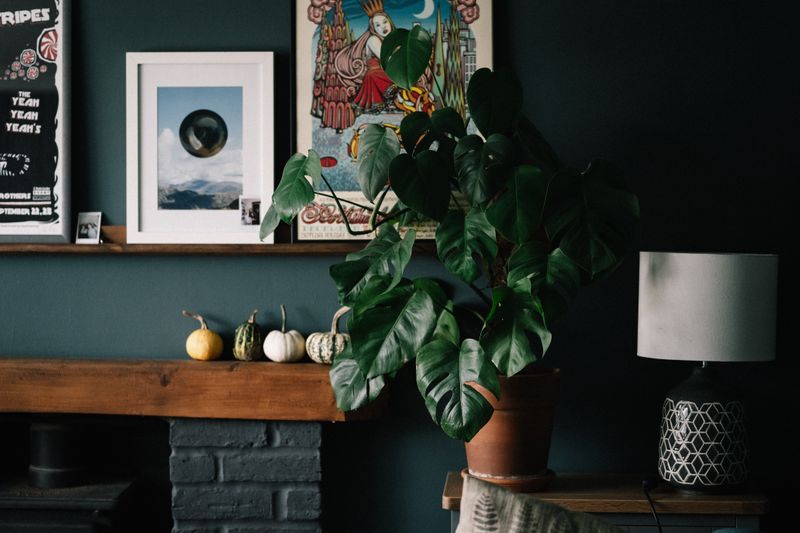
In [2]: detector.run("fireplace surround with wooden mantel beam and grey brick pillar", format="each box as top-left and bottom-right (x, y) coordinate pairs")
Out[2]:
(0, 358), (382, 533)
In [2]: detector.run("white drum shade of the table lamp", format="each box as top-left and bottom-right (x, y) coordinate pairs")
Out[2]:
(637, 252), (778, 362)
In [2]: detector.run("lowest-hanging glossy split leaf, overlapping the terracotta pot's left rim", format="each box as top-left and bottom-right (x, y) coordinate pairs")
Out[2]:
(417, 339), (500, 441)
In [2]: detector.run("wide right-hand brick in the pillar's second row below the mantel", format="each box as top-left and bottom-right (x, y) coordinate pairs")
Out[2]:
(221, 449), (321, 482)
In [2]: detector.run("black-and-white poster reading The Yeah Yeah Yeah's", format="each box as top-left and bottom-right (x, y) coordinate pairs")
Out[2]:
(0, 0), (71, 242)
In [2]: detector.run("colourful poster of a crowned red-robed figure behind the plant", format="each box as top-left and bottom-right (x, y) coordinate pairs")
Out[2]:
(296, 0), (492, 240)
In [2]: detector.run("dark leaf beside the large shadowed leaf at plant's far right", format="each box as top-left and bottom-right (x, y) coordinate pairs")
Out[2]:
(486, 165), (547, 244)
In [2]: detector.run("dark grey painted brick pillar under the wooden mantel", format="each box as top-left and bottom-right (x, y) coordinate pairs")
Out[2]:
(169, 418), (322, 533)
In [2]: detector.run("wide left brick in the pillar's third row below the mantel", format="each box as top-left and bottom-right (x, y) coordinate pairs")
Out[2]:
(172, 484), (272, 521)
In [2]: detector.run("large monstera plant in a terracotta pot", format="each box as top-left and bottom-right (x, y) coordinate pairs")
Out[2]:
(261, 27), (638, 488)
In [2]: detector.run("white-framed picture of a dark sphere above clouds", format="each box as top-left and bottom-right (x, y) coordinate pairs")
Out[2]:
(126, 52), (275, 244)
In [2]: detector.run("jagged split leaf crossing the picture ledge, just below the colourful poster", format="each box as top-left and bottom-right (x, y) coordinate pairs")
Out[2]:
(330, 225), (416, 306)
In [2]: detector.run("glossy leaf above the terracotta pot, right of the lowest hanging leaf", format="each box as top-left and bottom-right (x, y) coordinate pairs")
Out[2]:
(481, 284), (552, 376)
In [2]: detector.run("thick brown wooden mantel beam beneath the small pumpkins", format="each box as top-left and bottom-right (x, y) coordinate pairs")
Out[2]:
(0, 357), (380, 421)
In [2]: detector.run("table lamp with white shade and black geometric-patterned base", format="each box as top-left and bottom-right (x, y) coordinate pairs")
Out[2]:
(637, 252), (778, 491)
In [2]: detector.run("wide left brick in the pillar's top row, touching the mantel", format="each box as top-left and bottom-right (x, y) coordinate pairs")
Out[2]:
(169, 418), (268, 448)
